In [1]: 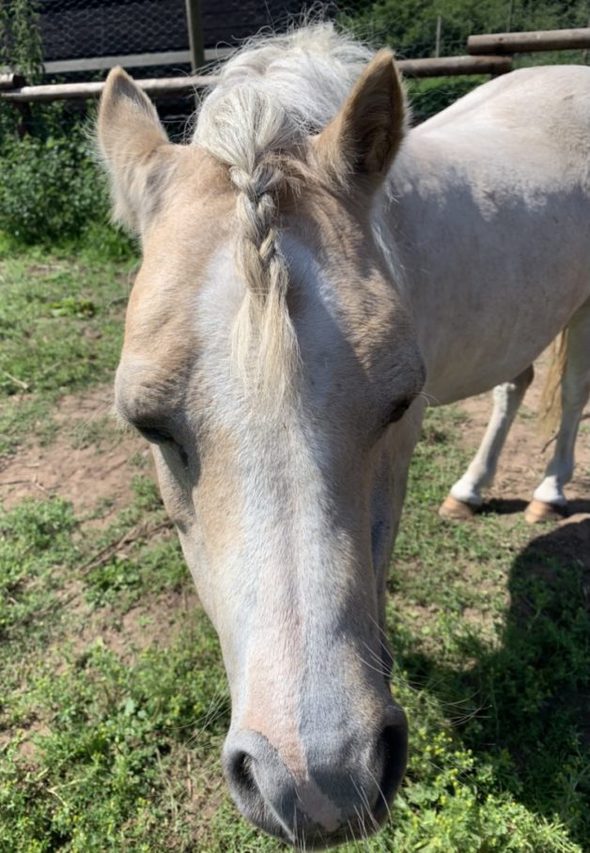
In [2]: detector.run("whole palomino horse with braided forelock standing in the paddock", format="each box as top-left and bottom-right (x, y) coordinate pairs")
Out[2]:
(97, 24), (590, 849)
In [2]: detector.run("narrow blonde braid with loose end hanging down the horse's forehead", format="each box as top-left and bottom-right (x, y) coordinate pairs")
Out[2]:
(230, 161), (298, 400)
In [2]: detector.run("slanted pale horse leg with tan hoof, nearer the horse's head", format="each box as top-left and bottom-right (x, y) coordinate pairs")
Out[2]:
(439, 365), (534, 519)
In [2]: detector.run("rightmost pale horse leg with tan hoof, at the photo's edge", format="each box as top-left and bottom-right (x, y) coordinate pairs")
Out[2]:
(525, 302), (590, 522)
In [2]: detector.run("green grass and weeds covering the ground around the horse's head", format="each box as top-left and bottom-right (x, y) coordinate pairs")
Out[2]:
(0, 243), (590, 853)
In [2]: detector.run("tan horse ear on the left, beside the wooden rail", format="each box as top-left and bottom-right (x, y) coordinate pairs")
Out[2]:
(97, 68), (174, 233)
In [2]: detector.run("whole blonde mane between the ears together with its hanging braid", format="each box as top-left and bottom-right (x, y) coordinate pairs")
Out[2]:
(193, 24), (371, 399)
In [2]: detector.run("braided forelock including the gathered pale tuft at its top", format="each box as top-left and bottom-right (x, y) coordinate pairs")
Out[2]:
(199, 84), (304, 400)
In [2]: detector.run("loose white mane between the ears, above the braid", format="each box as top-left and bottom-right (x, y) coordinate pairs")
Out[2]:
(193, 23), (371, 161)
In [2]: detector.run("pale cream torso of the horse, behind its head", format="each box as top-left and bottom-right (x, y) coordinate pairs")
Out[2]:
(385, 67), (590, 403)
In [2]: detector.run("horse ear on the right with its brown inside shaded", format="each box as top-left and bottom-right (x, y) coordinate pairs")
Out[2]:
(316, 50), (407, 181)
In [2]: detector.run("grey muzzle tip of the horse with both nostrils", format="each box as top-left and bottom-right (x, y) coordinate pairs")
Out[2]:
(223, 711), (407, 849)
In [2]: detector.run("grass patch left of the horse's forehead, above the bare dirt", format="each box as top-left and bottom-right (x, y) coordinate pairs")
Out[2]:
(0, 233), (136, 453)
